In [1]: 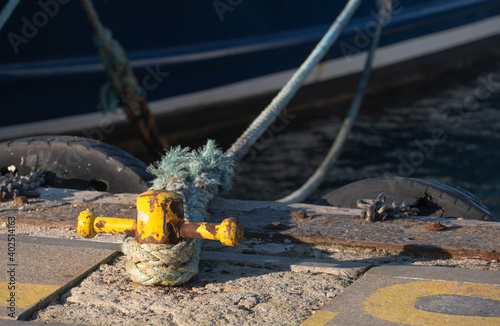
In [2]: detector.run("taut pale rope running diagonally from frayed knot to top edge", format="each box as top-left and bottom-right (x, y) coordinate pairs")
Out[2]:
(227, 0), (361, 164)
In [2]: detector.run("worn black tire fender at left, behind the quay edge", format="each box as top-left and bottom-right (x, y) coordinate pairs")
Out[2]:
(0, 136), (153, 193)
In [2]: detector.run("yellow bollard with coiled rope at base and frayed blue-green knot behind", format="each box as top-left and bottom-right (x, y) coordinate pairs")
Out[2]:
(78, 140), (244, 286)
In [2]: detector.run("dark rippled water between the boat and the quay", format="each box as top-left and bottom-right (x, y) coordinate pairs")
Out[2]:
(228, 62), (500, 215)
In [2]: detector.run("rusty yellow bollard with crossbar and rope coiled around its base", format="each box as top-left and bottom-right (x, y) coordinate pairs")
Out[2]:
(78, 190), (244, 285)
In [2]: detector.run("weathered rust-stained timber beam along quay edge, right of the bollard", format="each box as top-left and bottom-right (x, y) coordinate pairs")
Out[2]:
(232, 209), (500, 260)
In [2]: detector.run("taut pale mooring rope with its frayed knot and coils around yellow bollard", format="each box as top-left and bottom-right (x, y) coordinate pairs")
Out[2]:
(123, 0), (385, 285)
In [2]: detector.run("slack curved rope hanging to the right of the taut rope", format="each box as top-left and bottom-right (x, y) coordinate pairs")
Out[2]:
(277, 0), (391, 204)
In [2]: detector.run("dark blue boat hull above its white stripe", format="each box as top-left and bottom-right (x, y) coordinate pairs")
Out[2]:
(0, 0), (500, 136)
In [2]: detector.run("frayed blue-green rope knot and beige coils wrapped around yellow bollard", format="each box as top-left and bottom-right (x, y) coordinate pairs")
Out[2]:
(122, 140), (234, 286)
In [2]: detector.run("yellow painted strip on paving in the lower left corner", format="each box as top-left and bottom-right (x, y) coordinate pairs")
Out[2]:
(0, 282), (61, 308)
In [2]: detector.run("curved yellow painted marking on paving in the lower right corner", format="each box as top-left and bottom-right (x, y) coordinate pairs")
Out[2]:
(364, 281), (500, 326)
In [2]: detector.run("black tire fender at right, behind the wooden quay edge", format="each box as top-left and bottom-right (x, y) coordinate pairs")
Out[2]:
(315, 177), (500, 221)
